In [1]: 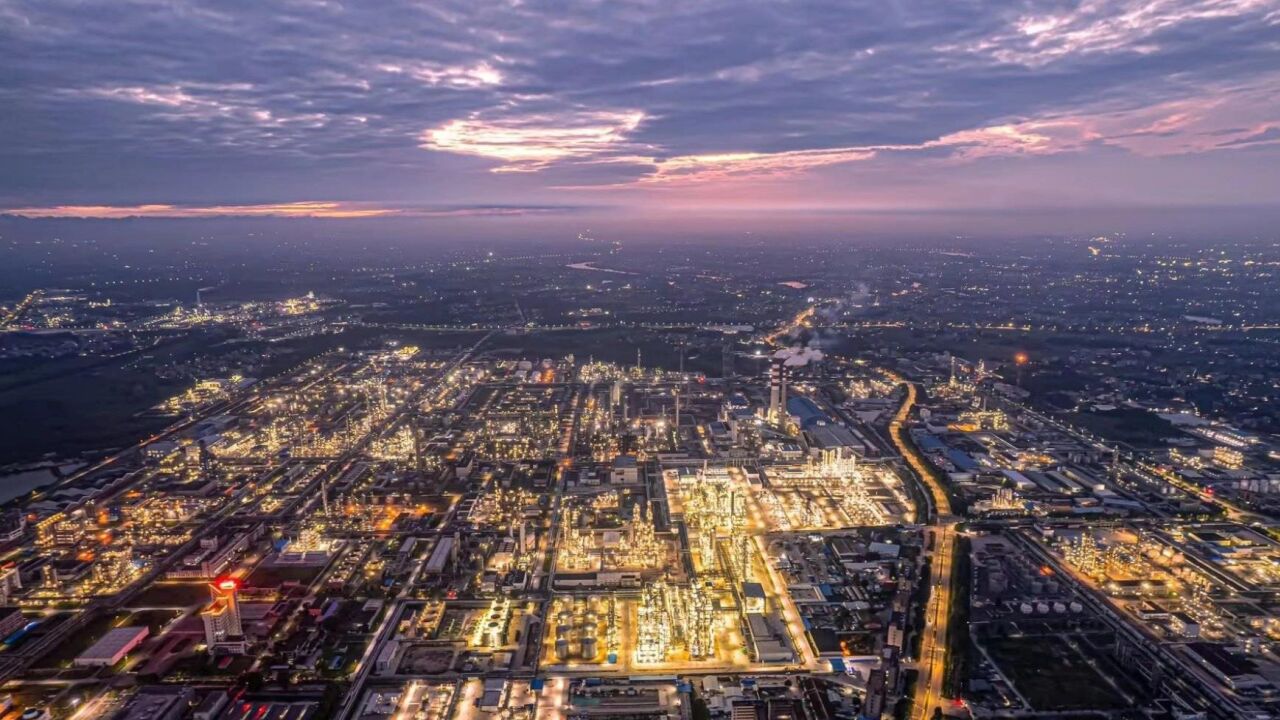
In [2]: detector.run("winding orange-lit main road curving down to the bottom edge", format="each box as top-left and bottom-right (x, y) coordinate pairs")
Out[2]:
(888, 373), (955, 720)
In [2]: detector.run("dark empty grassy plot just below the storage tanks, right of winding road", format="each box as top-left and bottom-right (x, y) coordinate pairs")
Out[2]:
(984, 635), (1125, 712)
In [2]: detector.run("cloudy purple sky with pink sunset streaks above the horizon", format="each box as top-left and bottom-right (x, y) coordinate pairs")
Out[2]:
(0, 0), (1280, 222)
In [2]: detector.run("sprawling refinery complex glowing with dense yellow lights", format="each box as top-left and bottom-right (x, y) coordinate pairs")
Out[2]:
(0, 303), (1280, 720)
